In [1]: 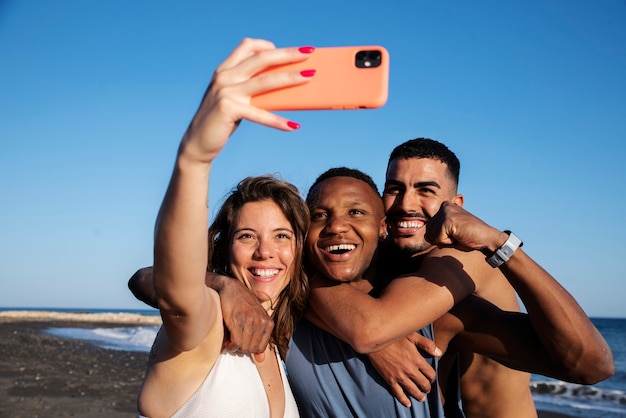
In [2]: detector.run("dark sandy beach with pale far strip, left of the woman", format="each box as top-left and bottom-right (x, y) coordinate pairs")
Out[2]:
(0, 312), (566, 418)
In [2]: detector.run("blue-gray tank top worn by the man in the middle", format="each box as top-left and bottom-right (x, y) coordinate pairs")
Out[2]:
(286, 320), (444, 418)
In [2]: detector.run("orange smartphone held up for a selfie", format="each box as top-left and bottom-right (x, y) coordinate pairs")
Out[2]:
(251, 46), (389, 110)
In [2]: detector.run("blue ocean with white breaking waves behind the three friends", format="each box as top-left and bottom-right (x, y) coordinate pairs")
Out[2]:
(6, 309), (626, 418)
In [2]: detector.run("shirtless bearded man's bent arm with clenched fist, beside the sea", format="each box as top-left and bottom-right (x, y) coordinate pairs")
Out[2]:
(427, 204), (615, 383)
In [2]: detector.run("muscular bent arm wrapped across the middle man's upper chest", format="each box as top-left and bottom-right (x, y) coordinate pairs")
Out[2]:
(309, 249), (484, 353)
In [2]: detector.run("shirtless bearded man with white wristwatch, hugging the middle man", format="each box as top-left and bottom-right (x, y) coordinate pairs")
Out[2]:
(307, 139), (614, 418)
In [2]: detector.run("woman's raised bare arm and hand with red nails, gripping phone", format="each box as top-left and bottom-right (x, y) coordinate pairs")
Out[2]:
(153, 39), (309, 351)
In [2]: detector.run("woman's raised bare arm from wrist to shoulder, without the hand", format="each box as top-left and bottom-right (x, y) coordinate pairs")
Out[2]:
(153, 146), (221, 351)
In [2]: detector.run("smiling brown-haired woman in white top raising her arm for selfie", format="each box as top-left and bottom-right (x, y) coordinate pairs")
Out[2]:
(138, 39), (311, 418)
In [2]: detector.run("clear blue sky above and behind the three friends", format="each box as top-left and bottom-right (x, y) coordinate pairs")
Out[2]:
(0, 0), (626, 317)
